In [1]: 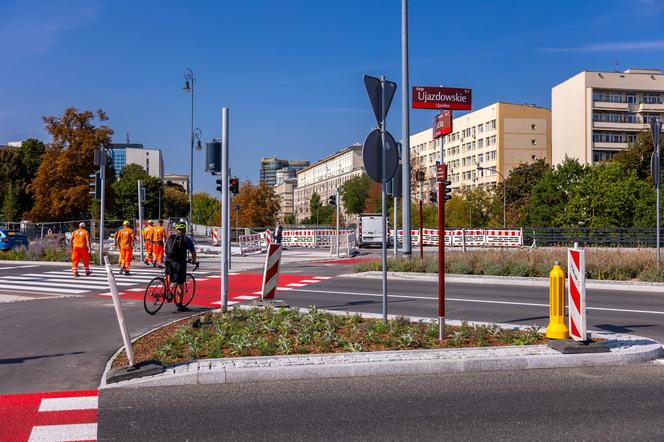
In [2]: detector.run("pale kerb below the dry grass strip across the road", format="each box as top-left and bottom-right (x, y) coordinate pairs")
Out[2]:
(338, 272), (664, 293)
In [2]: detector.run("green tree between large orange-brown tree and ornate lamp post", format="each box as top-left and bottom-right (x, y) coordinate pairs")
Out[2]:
(111, 164), (163, 219)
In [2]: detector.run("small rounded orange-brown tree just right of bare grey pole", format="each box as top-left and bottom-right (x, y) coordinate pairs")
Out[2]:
(231, 181), (281, 227)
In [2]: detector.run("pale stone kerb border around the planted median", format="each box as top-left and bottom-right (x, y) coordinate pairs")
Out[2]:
(99, 309), (664, 389)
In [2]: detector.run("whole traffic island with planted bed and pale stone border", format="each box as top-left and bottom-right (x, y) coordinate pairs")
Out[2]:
(100, 306), (662, 388)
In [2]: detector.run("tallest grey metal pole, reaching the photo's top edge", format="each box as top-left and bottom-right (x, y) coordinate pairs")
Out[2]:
(401, 0), (412, 256)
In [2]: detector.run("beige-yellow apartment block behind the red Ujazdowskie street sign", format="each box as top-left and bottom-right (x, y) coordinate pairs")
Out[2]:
(410, 102), (551, 195)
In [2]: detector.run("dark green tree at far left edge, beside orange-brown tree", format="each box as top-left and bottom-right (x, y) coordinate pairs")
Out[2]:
(0, 138), (46, 221)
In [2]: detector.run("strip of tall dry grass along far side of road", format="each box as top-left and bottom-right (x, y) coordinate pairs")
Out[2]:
(353, 249), (664, 282)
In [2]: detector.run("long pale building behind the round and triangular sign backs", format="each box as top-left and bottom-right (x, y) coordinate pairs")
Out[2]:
(294, 144), (364, 222)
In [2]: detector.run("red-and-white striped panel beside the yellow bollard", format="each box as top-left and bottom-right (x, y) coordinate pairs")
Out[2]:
(567, 248), (588, 341)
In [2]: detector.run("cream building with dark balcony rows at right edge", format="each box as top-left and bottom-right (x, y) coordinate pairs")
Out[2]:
(551, 69), (664, 165)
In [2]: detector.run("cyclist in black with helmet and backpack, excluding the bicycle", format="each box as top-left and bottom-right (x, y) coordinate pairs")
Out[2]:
(164, 223), (196, 311)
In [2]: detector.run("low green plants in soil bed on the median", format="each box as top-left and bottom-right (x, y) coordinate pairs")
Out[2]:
(113, 307), (546, 367)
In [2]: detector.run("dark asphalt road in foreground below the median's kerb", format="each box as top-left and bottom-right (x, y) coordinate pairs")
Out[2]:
(98, 364), (664, 441)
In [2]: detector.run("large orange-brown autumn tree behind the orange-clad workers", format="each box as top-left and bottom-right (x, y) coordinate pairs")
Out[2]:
(28, 108), (113, 221)
